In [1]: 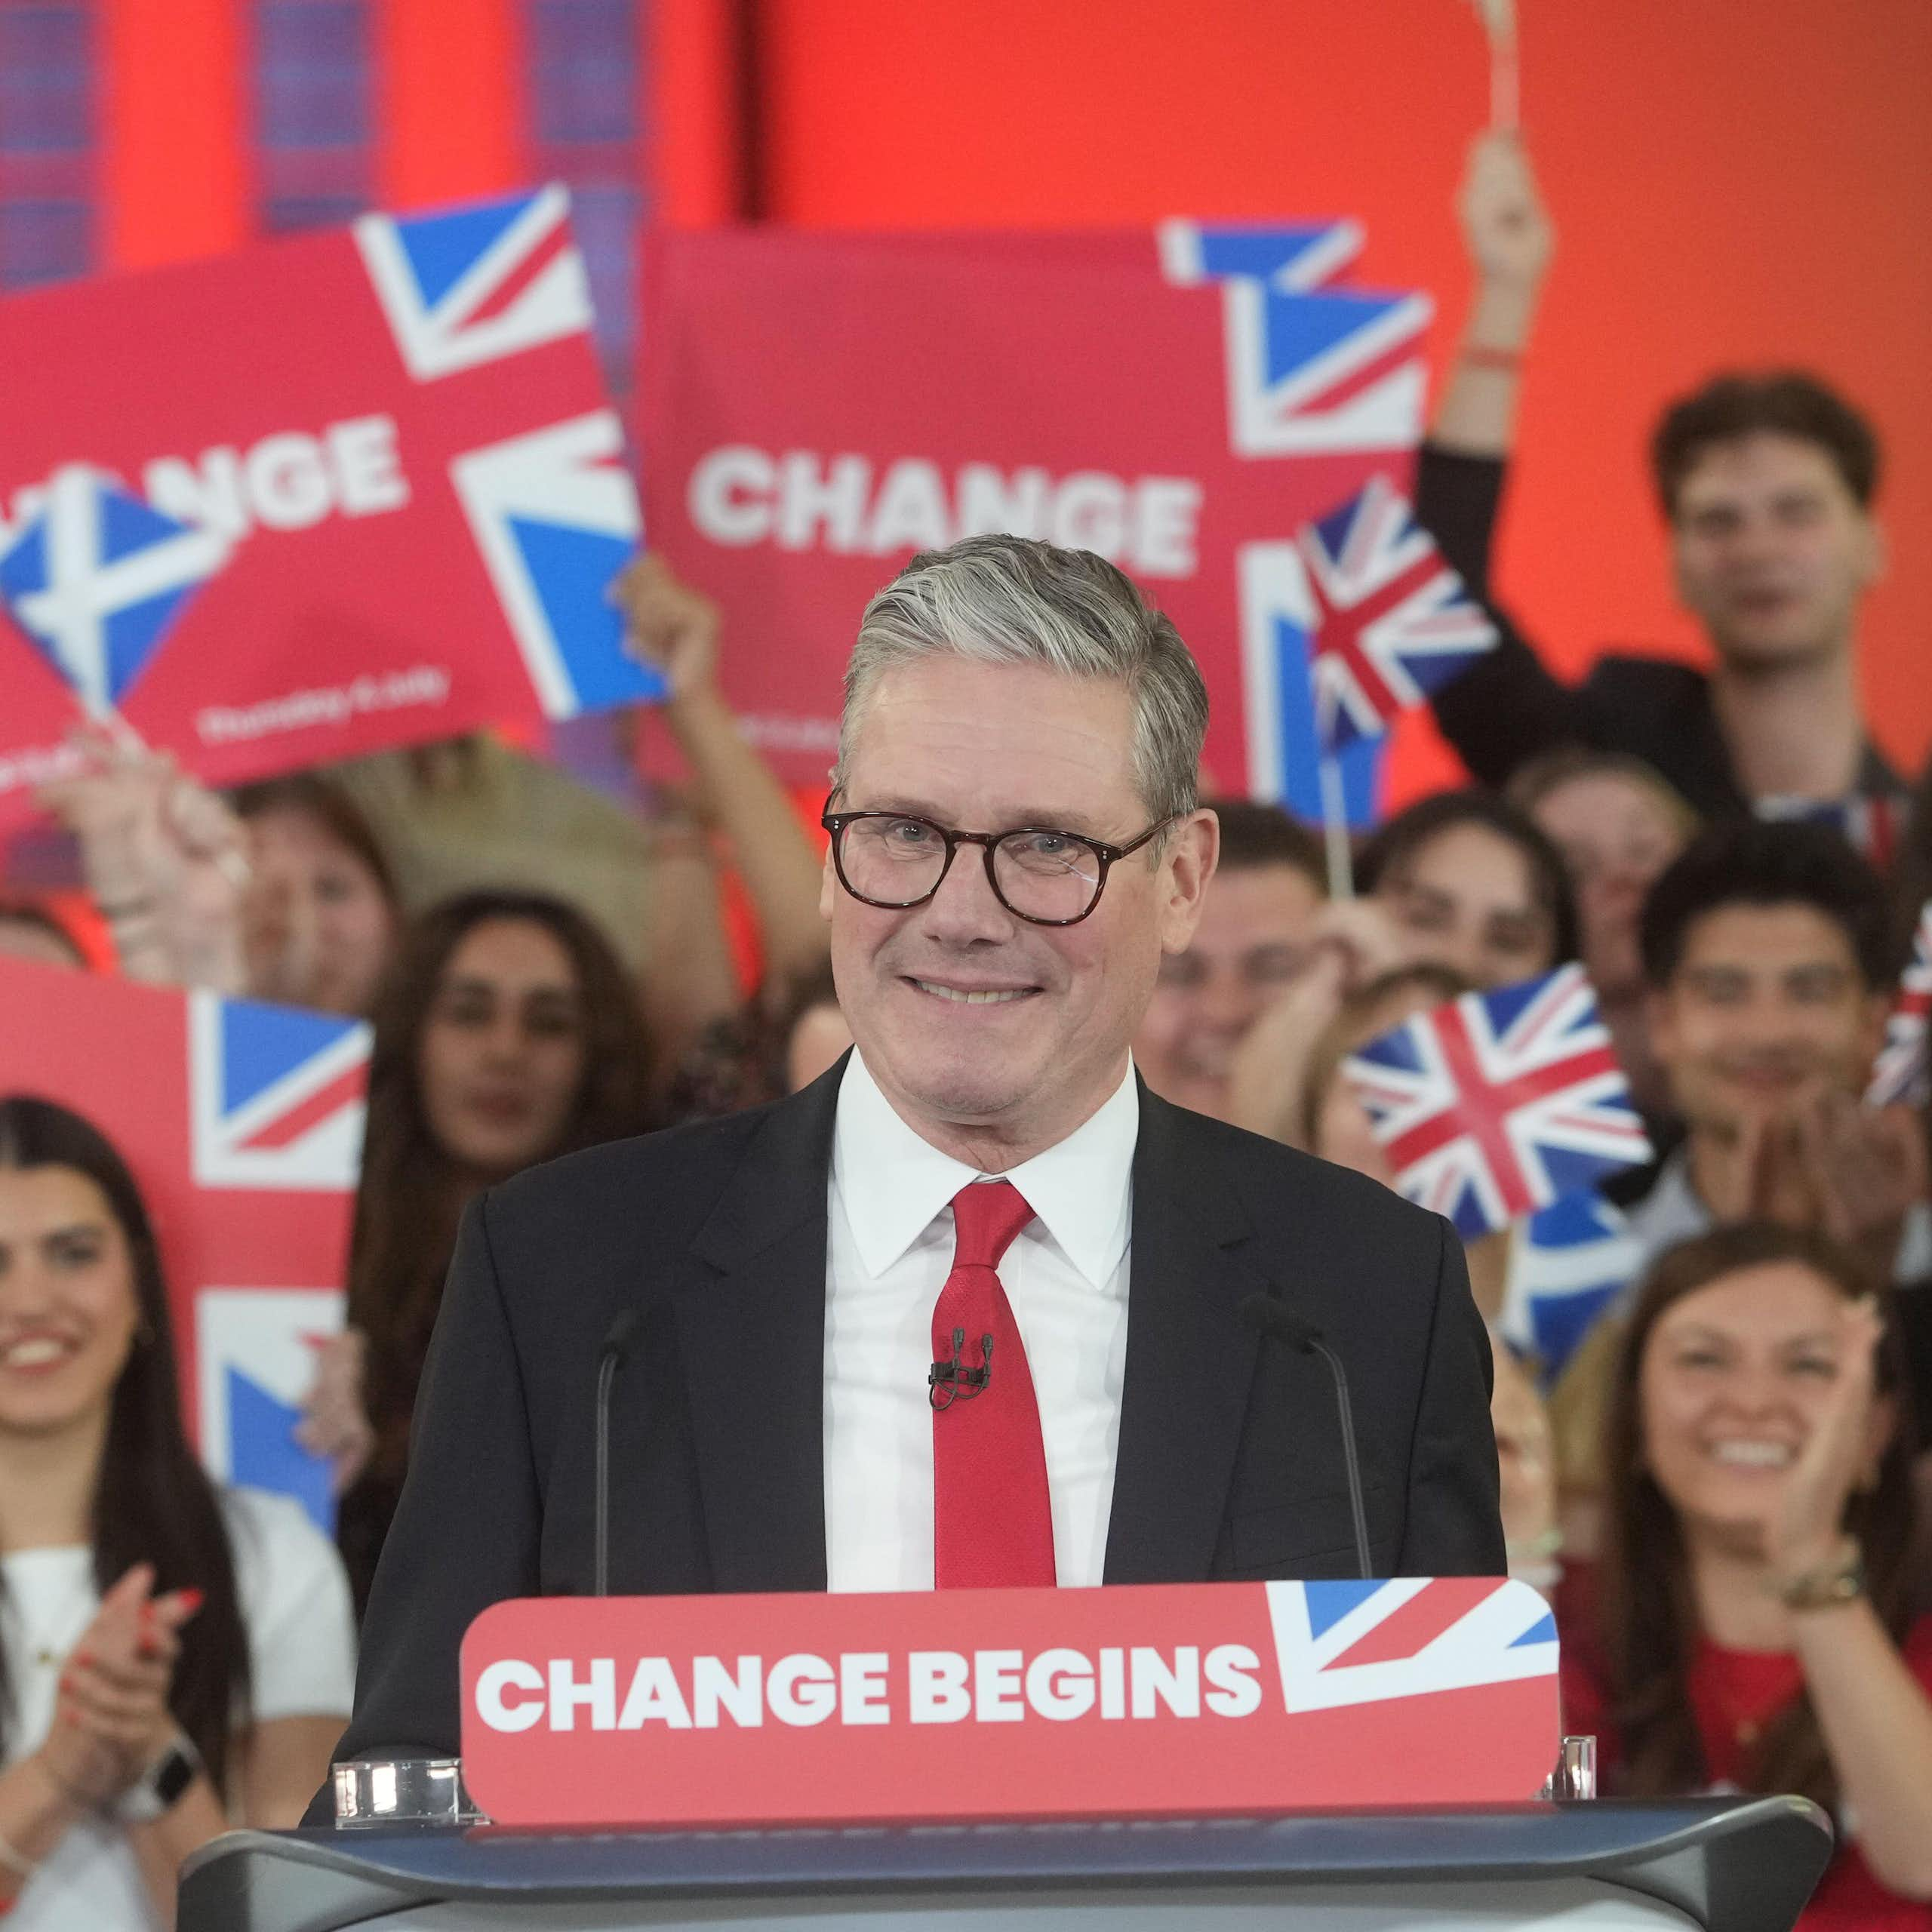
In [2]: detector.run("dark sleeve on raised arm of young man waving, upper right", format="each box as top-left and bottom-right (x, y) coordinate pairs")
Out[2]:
(1416, 445), (1601, 784)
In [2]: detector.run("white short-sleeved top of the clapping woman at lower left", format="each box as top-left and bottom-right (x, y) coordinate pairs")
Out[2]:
(0, 1490), (355, 1932)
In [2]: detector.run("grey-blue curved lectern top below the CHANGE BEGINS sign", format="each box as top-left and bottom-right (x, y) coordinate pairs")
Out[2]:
(178, 1798), (1832, 1932)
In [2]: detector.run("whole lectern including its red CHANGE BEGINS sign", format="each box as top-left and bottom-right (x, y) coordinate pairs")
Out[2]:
(178, 1577), (1832, 1932)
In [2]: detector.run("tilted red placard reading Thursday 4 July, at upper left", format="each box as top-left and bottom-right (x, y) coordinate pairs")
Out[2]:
(0, 189), (657, 819)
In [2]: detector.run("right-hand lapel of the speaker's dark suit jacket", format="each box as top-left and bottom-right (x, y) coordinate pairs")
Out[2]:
(1105, 1086), (1267, 1583)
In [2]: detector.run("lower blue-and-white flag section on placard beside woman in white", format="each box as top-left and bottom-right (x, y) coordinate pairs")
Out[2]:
(195, 1289), (344, 1531)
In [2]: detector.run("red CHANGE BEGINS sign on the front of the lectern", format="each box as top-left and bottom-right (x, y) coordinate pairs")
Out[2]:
(462, 1577), (1559, 1826)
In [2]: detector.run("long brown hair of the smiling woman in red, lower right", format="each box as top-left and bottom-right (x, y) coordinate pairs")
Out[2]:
(1600, 1221), (1912, 1808)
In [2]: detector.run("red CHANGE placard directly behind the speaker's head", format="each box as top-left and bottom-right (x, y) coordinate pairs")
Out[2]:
(639, 224), (1428, 814)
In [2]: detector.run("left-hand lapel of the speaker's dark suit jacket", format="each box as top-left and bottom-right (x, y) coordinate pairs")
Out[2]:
(674, 1060), (844, 1590)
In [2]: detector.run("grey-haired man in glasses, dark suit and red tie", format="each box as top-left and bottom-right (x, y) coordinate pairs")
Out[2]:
(338, 537), (1503, 1756)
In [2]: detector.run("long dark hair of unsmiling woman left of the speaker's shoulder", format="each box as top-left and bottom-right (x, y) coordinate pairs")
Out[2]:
(349, 891), (651, 1474)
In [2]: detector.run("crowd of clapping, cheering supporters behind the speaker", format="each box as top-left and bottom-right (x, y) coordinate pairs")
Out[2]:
(0, 137), (1932, 1926)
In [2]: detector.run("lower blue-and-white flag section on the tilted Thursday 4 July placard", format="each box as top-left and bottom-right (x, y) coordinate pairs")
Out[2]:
(450, 410), (665, 718)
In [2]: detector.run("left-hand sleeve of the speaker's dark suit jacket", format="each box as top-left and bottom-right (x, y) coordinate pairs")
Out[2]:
(307, 1196), (541, 1824)
